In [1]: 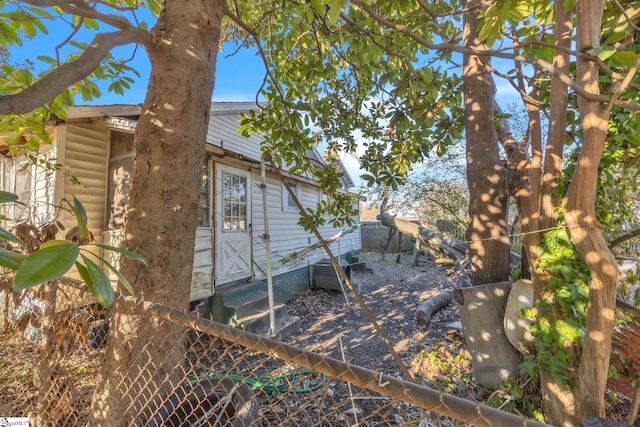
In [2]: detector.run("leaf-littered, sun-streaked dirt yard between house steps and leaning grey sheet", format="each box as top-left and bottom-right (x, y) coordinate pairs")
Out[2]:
(288, 252), (482, 398)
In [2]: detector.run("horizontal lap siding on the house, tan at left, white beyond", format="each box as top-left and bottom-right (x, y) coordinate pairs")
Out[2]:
(33, 106), (360, 308)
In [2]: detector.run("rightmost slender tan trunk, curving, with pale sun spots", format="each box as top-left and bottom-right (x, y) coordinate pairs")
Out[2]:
(563, 0), (618, 421)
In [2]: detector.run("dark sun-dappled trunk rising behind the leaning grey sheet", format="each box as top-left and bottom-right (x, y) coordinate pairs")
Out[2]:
(463, 0), (509, 285)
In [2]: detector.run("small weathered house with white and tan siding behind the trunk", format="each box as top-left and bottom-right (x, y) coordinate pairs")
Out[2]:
(1, 102), (360, 332)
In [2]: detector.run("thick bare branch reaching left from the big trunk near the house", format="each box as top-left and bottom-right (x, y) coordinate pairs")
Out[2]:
(0, 30), (151, 115)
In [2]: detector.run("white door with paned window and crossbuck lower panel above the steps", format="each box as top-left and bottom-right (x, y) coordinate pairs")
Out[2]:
(215, 165), (252, 285)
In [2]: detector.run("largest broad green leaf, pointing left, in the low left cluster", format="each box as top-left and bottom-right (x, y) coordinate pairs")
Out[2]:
(13, 241), (80, 290)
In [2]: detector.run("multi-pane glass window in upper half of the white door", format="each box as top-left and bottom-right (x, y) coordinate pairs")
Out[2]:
(222, 172), (248, 231)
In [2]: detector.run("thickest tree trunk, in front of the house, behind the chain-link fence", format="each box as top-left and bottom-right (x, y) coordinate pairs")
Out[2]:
(87, 0), (224, 425)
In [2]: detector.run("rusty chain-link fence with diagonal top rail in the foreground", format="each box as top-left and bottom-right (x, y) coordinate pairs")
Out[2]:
(0, 284), (542, 426)
